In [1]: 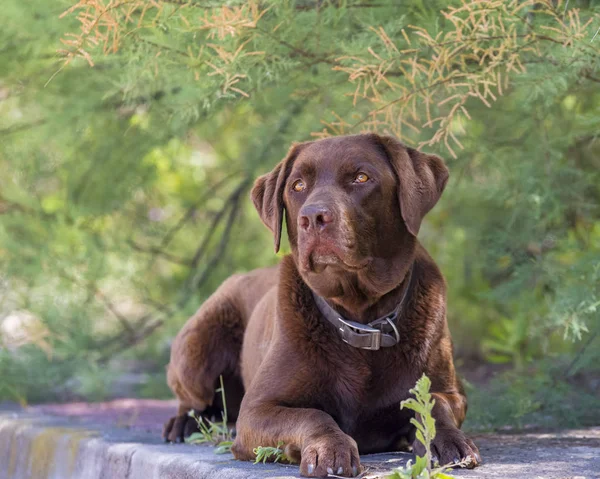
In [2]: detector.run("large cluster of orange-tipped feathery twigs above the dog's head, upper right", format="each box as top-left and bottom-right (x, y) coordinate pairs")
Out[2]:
(322, 0), (600, 157)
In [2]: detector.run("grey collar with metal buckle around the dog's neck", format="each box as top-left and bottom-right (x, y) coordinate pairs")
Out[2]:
(313, 266), (412, 351)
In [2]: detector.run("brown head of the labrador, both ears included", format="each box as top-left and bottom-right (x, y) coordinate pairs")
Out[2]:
(252, 134), (448, 297)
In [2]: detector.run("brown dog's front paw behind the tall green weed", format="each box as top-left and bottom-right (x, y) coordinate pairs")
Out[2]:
(413, 428), (482, 469)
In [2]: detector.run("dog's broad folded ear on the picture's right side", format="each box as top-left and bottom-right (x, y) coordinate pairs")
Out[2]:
(375, 135), (450, 236)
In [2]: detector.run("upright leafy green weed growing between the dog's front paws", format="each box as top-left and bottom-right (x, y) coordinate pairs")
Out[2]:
(386, 374), (471, 479)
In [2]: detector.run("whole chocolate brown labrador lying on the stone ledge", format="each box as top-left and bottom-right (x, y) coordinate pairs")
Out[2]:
(164, 134), (481, 477)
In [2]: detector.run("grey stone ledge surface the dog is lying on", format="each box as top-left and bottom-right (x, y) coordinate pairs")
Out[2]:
(0, 400), (600, 479)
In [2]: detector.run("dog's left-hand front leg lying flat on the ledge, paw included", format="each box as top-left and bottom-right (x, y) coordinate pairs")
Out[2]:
(232, 404), (360, 477)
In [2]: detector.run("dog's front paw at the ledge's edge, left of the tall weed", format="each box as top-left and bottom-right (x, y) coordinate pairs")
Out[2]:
(300, 434), (361, 477)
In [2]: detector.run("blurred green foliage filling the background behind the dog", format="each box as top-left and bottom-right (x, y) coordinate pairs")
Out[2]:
(0, 0), (600, 430)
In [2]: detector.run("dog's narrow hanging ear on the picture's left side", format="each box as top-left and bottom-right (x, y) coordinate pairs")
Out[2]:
(250, 143), (302, 253)
